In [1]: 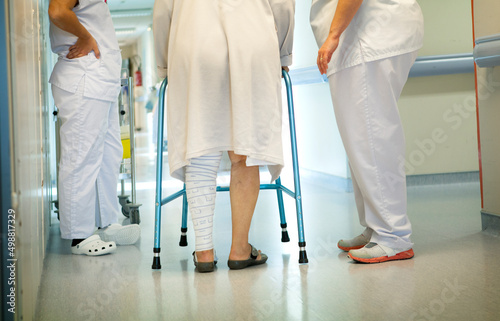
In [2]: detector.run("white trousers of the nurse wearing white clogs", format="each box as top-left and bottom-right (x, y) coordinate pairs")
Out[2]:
(52, 79), (123, 239)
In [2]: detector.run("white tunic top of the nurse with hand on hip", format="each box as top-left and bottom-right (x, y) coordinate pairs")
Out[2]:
(49, 0), (122, 101)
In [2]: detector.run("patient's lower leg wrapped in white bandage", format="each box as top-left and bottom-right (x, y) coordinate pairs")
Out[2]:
(186, 152), (222, 252)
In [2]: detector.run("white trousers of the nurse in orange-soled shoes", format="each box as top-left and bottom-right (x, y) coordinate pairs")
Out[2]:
(328, 52), (417, 249)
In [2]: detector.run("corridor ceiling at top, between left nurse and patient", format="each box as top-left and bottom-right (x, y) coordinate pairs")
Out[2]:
(108, 0), (154, 46)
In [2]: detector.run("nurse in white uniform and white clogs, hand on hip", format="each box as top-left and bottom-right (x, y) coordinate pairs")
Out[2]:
(49, 0), (140, 255)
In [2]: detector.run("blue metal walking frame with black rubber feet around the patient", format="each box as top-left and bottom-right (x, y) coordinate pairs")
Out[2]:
(152, 70), (308, 270)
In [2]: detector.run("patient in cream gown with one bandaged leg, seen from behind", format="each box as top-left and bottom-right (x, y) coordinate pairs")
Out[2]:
(153, 0), (295, 272)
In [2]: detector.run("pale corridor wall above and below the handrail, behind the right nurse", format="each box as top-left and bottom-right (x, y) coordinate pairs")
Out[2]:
(292, 0), (478, 186)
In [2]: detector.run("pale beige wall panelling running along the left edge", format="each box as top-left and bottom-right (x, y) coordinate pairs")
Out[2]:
(9, 0), (50, 320)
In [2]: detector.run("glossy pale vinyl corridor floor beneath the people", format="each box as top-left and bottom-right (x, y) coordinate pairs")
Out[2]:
(36, 126), (500, 321)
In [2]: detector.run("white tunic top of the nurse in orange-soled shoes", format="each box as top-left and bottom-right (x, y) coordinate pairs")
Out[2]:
(310, 0), (424, 76)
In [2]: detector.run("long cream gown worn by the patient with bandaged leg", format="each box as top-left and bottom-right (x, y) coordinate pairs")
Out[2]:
(153, 0), (295, 180)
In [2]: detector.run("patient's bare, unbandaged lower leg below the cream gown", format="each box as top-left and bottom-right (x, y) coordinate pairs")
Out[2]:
(228, 151), (261, 260)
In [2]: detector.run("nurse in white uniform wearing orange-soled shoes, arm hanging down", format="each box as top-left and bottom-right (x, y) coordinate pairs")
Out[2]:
(311, 0), (423, 263)
